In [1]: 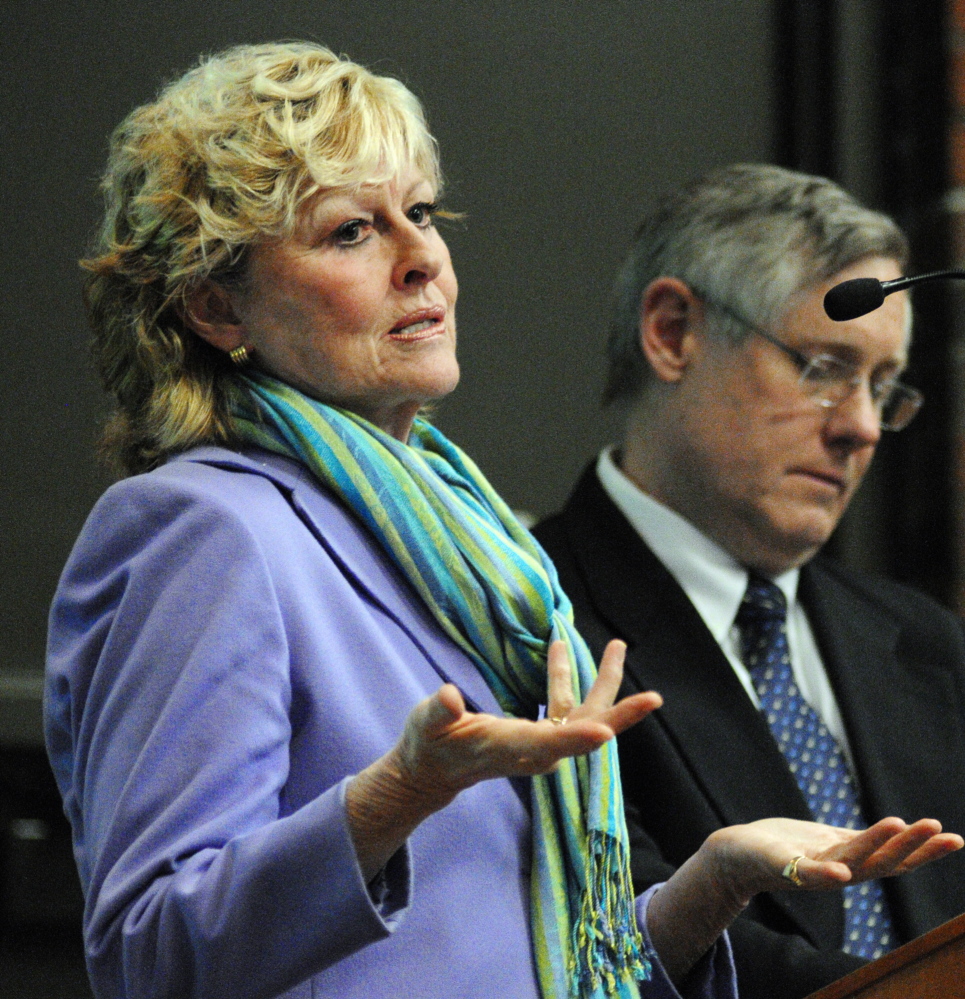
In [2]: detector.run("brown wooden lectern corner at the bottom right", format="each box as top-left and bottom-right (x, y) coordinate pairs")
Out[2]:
(808, 914), (965, 999)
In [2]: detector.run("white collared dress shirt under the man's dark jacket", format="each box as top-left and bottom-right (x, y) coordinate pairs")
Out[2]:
(596, 447), (854, 771)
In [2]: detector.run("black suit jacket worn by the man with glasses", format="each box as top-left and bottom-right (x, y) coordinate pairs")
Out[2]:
(535, 468), (965, 999)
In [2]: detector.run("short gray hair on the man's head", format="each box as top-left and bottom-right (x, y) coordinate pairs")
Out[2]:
(603, 163), (908, 403)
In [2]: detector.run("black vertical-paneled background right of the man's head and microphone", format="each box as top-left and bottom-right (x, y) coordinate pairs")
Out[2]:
(773, 0), (965, 610)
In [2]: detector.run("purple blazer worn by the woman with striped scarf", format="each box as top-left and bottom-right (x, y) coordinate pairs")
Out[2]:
(45, 448), (734, 999)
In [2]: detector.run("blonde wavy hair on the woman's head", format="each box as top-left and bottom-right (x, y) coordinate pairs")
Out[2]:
(81, 42), (441, 474)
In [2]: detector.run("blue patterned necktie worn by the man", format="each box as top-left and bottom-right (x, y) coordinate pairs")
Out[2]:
(736, 574), (894, 960)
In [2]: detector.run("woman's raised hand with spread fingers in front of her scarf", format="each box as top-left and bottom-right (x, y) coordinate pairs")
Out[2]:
(346, 640), (663, 879)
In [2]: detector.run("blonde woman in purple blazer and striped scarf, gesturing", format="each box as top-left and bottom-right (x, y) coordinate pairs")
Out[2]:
(47, 44), (961, 999)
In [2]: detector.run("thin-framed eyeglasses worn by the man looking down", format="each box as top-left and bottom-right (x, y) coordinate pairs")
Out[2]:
(691, 289), (925, 433)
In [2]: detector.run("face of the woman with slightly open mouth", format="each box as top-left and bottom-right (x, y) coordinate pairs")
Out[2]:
(231, 169), (459, 440)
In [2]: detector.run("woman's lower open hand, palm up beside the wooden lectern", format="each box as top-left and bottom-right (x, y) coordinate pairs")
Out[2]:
(647, 818), (963, 981)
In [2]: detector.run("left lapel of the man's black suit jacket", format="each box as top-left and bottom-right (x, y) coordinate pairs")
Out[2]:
(564, 469), (843, 941)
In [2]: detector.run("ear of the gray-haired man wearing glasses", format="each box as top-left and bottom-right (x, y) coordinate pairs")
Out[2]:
(640, 277), (704, 382)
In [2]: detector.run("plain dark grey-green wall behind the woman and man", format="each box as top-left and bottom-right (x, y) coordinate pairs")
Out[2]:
(0, 0), (774, 684)
